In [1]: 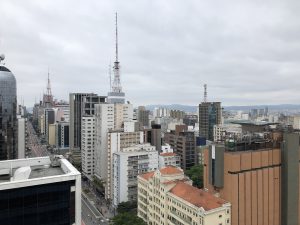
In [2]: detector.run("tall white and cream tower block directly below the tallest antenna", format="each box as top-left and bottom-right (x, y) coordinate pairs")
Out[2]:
(95, 104), (133, 180)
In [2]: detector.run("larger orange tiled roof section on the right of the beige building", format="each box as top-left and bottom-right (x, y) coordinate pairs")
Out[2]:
(170, 181), (227, 211)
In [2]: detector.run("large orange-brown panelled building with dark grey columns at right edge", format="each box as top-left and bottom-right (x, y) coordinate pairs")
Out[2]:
(204, 132), (300, 225)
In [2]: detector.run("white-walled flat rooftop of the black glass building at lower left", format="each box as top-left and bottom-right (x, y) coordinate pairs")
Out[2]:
(0, 156), (80, 186)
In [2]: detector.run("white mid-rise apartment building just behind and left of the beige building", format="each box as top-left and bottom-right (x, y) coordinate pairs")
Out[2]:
(112, 144), (158, 208)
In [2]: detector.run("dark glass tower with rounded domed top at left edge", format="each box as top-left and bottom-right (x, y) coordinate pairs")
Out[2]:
(0, 58), (18, 160)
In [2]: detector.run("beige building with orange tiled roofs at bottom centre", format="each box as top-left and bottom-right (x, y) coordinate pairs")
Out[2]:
(138, 166), (231, 225)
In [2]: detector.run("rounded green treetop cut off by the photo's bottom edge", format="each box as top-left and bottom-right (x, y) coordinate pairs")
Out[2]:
(110, 212), (146, 225)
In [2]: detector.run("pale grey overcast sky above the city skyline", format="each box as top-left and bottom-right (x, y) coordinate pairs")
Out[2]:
(0, 0), (300, 106)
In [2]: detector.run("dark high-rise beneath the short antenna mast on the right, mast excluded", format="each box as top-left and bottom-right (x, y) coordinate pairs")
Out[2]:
(199, 102), (222, 141)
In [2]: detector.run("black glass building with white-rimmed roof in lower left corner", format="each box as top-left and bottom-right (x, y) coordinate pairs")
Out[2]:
(0, 156), (81, 225)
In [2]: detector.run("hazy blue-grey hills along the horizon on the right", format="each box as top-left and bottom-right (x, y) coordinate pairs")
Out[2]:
(146, 104), (300, 112)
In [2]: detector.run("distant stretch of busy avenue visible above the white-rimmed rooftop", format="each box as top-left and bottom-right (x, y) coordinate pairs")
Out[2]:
(26, 121), (49, 157)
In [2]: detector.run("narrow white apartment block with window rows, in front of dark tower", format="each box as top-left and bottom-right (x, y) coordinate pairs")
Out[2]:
(81, 116), (95, 180)
